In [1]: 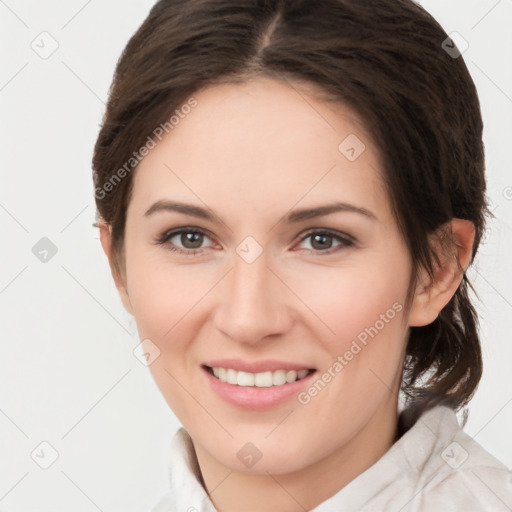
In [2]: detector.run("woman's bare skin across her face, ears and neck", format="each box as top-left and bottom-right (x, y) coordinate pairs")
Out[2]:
(100, 78), (474, 512)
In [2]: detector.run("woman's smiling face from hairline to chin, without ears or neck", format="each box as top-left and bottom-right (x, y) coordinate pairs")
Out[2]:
(113, 79), (411, 473)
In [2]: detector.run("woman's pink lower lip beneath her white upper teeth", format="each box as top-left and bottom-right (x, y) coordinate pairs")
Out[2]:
(201, 368), (316, 411)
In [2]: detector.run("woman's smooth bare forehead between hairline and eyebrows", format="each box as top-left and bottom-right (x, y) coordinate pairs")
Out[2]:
(132, 78), (389, 226)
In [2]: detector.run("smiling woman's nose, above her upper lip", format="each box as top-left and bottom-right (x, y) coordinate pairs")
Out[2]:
(214, 247), (293, 345)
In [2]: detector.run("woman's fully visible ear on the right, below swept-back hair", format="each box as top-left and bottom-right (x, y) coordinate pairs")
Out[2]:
(409, 219), (475, 327)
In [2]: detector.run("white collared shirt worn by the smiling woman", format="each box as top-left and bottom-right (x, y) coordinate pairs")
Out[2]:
(151, 406), (512, 512)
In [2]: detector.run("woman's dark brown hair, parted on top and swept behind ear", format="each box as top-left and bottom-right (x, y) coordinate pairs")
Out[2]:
(93, 0), (490, 429)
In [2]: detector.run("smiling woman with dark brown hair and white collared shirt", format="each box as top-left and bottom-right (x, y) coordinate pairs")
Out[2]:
(93, 0), (512, 512)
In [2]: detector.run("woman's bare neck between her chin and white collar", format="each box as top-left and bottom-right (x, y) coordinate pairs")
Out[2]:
(195, 398), (398, 512)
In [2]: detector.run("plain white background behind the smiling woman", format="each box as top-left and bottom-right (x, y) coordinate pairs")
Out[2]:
(0, 0), (512, 512)
